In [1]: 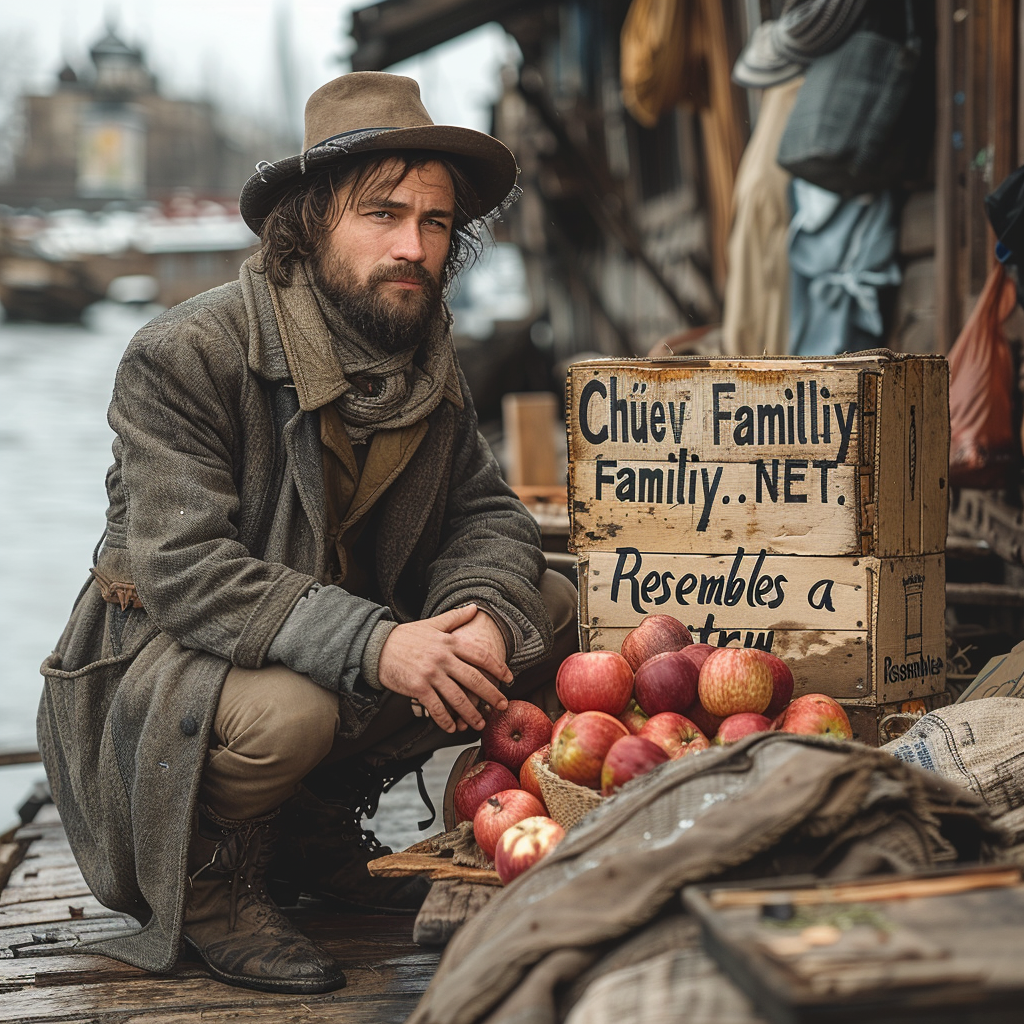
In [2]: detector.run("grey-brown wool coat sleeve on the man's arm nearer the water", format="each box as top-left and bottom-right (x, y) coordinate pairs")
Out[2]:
(109, 315), (387, 676)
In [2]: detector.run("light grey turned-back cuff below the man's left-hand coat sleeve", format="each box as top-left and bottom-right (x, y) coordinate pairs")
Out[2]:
(267, 585), (396, 695)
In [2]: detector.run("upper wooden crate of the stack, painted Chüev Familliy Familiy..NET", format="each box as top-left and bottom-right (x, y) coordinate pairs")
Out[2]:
(566, 356), (949, 556)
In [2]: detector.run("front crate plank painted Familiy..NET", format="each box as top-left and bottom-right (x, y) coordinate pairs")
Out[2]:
(571, 454), (863, 555)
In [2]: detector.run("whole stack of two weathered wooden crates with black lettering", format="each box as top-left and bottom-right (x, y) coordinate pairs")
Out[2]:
(566, 353), (949, 745)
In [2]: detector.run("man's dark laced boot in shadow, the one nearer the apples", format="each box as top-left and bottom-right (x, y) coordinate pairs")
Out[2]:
(270, 758), (430, 913)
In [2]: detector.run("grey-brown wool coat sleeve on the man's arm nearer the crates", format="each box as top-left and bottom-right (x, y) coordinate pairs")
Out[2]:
(424, 381), (552, 671)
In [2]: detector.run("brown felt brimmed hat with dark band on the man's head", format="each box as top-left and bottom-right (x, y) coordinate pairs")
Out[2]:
(239, 71), (518, 234)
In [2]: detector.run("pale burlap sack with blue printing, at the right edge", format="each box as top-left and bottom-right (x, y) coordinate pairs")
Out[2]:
(880, 697), (1024, 833)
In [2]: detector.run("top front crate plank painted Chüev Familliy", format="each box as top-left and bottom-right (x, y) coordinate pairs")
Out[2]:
(568, 358), (880, 463)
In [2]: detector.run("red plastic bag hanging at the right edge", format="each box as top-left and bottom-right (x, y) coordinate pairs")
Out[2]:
(949, 263), (1017, 487)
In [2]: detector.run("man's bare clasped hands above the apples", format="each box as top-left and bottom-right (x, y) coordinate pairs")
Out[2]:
(377, 604), (512, 732)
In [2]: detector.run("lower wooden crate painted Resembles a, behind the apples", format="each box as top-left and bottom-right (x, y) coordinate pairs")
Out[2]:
(580, 547), (945, 703)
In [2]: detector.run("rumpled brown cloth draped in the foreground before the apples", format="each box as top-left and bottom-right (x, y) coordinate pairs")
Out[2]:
(409, 733), (1002, 1024)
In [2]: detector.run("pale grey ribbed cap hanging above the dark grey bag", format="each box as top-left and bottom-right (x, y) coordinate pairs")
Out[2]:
(732, 0), (867, 89)
